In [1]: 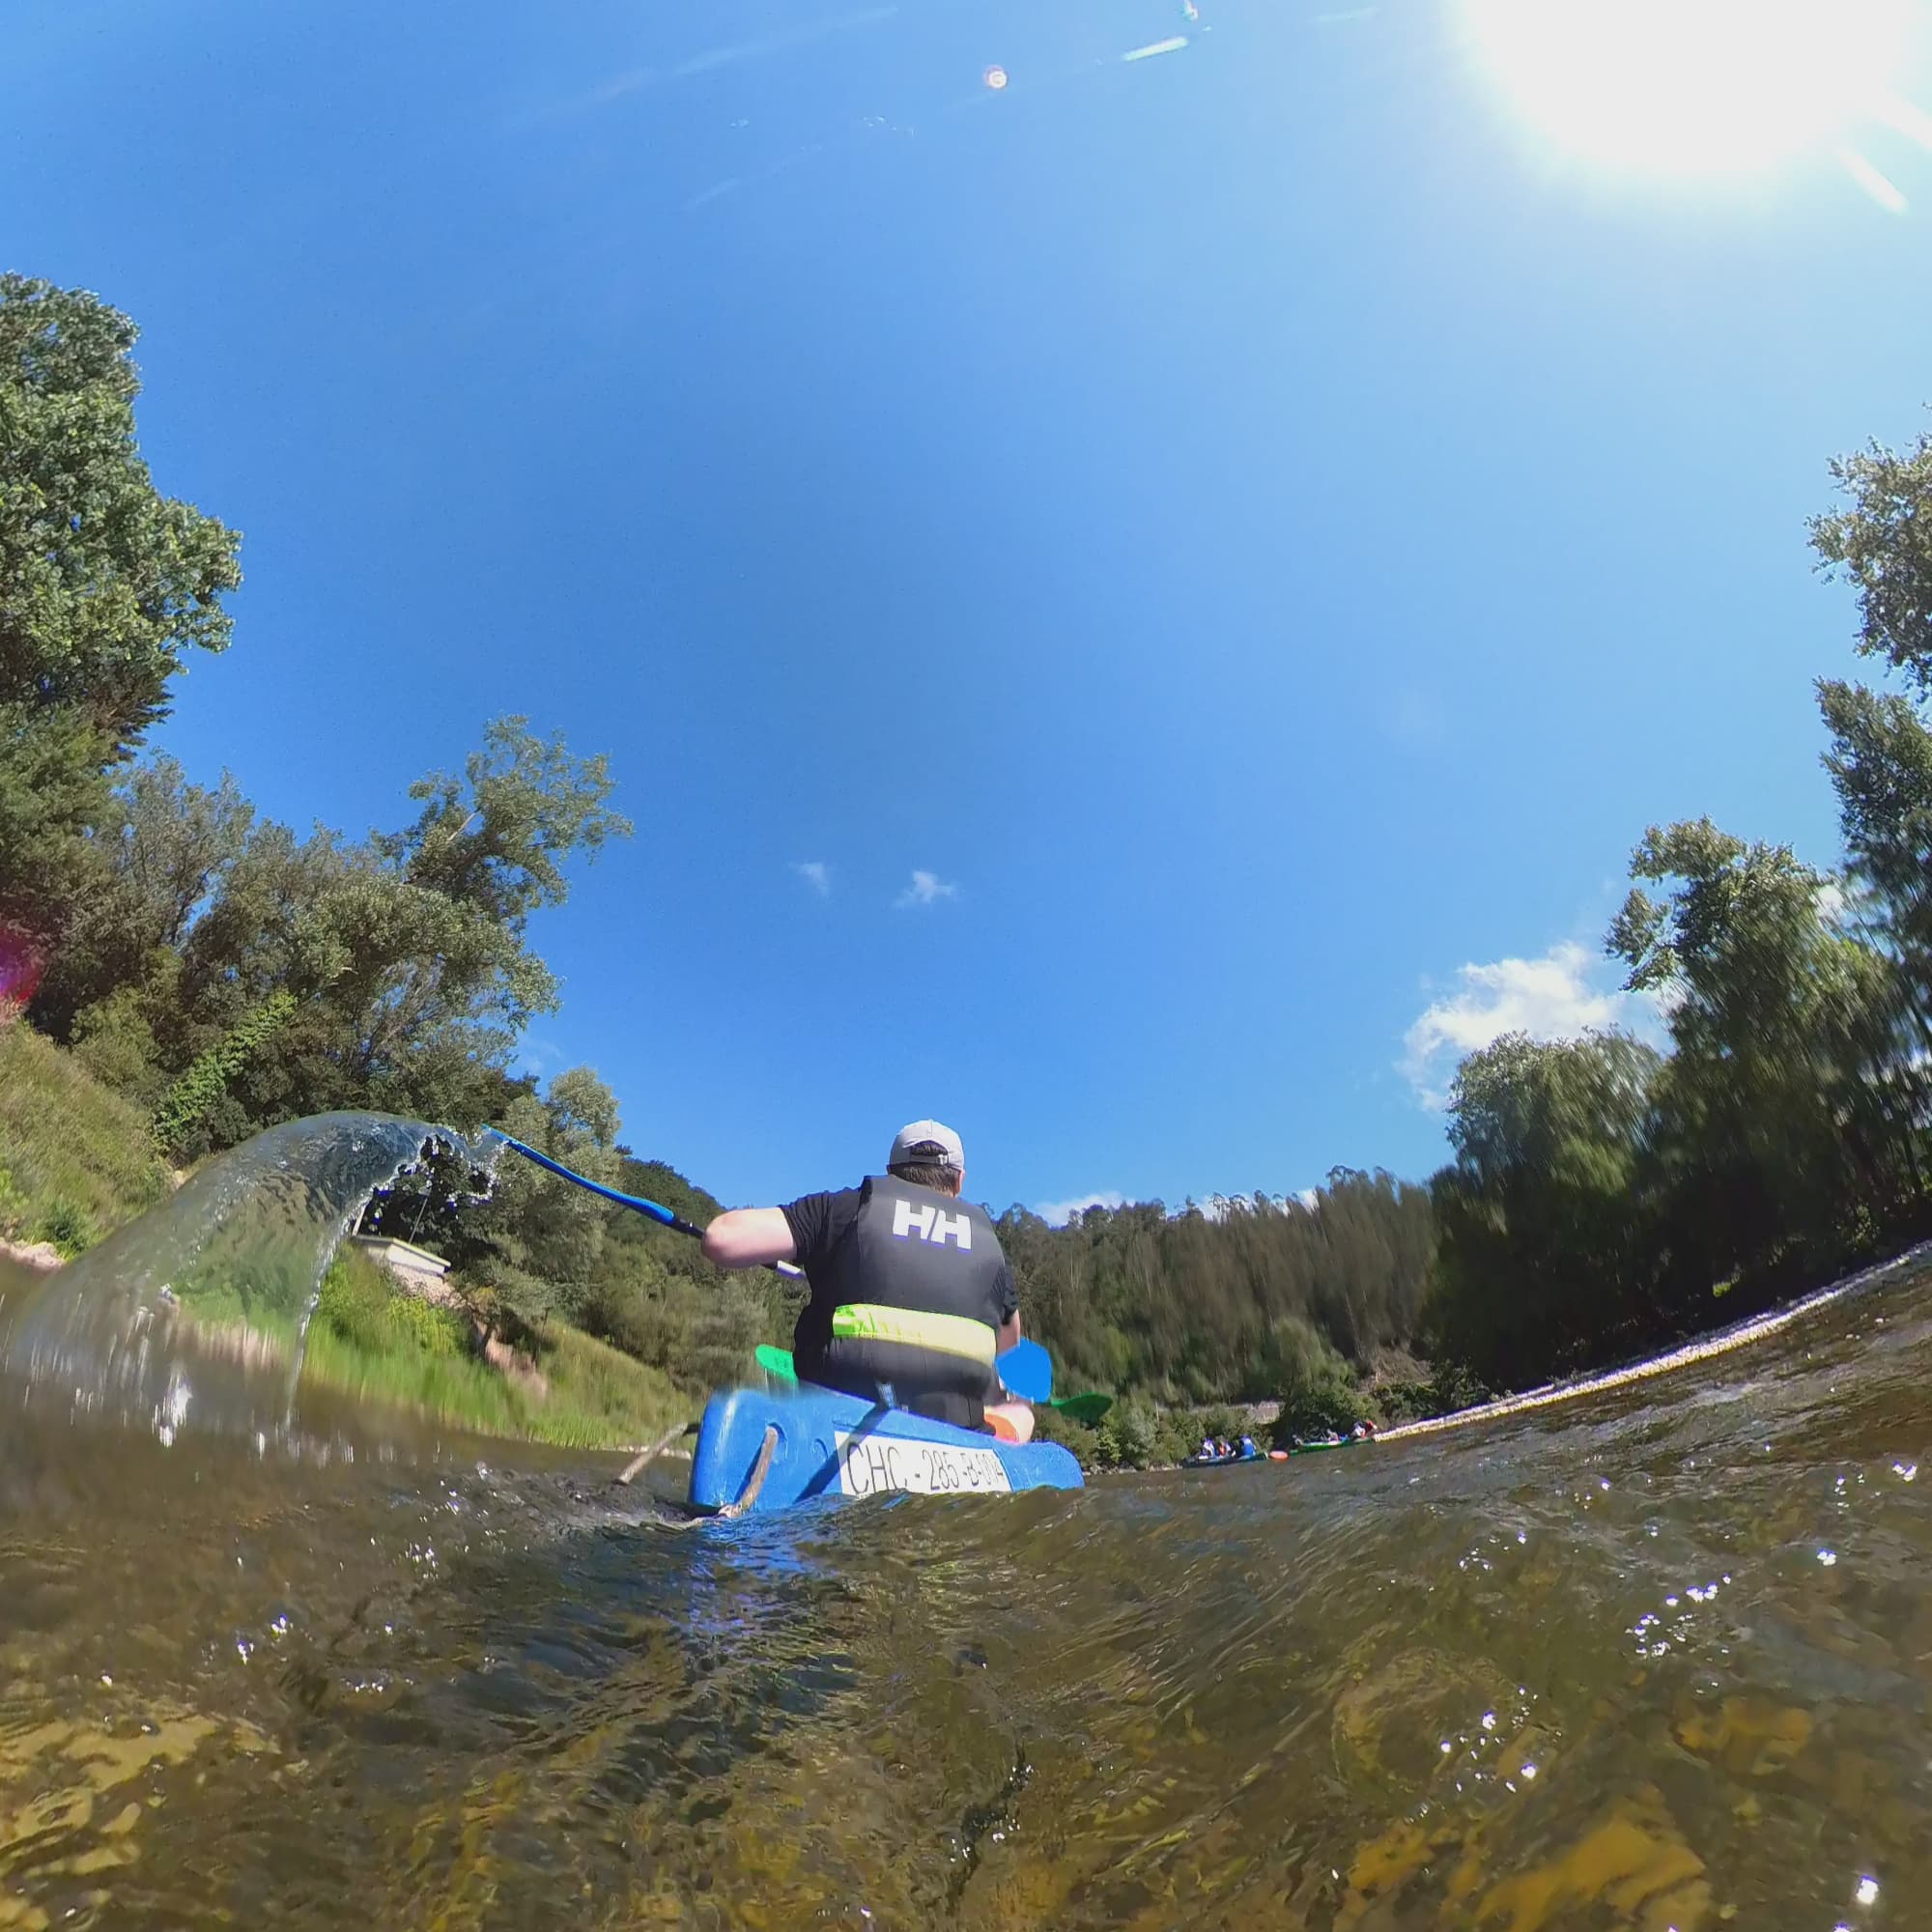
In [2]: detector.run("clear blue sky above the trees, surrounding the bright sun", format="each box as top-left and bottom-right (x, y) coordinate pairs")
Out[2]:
(11, 0), (1932, 1208)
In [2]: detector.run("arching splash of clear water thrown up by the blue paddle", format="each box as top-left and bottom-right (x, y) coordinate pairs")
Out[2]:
(0, 1113), (497, 1443)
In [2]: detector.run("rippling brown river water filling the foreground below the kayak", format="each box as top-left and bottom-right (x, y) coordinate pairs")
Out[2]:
(0, 1244), (1932, 1932)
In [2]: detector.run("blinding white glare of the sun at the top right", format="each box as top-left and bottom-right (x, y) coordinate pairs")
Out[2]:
(1464, 0), (1907, 174)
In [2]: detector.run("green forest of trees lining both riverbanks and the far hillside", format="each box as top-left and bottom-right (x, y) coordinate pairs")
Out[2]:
(11, 276), (1932, 1455)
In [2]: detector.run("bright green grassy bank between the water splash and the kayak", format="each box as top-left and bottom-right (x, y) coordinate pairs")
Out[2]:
(301, 1248), (696, 1449)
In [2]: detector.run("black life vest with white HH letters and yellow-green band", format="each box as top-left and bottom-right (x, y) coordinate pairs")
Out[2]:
(796, 1175), (1007, 1430)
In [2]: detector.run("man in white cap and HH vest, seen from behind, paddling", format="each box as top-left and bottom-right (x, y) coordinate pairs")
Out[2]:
(705, 1121), (1034, 1443)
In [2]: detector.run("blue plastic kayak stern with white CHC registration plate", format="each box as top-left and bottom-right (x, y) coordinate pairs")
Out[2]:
(690, 1383), (1084, 1515)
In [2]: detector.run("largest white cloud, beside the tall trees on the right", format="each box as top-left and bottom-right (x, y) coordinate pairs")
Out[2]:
(1397, 939), (1658, 1113)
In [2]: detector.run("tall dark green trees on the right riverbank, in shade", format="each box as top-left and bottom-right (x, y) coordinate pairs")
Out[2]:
(1422, 437), (1932, 1385)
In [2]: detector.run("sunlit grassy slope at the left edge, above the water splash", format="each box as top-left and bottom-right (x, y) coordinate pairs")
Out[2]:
(0, 1020), (168, 1256)
